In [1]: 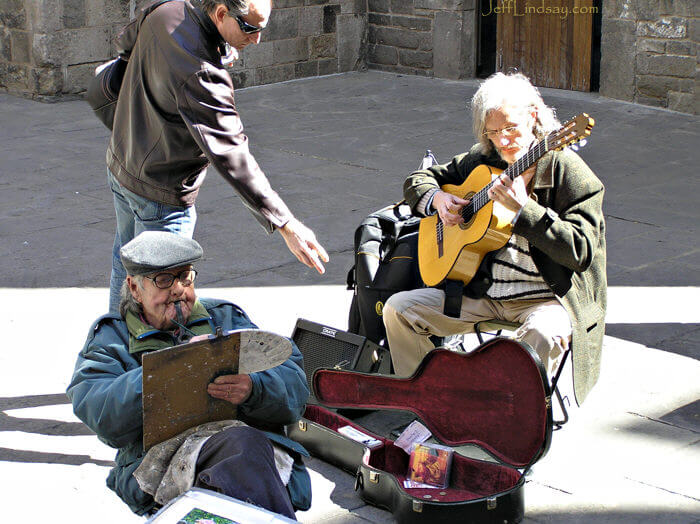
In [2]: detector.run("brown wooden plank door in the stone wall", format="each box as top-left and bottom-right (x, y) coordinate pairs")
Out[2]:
(491, 0), (599, 91)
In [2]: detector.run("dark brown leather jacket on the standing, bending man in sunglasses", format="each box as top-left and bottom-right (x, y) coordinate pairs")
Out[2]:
(107, 0), (292, 232)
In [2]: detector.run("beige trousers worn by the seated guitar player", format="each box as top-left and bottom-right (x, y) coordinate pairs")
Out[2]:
(383, 288), (571, 380)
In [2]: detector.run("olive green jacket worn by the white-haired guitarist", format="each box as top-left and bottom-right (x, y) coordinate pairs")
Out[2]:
(404, 144), (607, 404)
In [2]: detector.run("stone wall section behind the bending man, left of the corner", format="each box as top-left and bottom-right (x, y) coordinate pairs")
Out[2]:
(0, 0), (367, 100)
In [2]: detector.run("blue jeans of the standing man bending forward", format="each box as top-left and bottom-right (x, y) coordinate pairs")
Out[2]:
(107, 171), (197, 313)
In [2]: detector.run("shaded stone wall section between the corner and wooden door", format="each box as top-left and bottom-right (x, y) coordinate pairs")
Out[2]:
(367, 0), (476, 79)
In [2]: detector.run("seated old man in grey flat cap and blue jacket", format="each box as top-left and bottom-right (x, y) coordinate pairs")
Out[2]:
(67, 231), (311, 519)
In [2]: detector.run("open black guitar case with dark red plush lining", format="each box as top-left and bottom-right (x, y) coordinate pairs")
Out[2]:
(287, 338), (552, 524)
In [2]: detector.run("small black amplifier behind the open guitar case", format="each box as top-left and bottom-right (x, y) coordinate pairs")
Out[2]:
(292, 318), (391, 400)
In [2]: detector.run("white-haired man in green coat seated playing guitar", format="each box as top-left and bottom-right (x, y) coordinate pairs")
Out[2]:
(384, 73), (607, 404)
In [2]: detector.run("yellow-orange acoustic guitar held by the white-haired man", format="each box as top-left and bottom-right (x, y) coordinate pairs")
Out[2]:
(418, 113), (595, 286)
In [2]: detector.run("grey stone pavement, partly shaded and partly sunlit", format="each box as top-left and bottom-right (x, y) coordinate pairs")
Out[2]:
(0, 72), (700, 524)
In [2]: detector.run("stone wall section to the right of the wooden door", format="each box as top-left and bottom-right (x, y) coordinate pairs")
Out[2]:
(600, 0), (700, 114)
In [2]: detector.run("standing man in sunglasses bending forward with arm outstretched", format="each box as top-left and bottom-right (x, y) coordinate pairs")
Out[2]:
(107, 0), (328, 313)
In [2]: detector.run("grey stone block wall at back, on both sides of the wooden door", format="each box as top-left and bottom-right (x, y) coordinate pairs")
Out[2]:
(0, 0), (700, 114)
